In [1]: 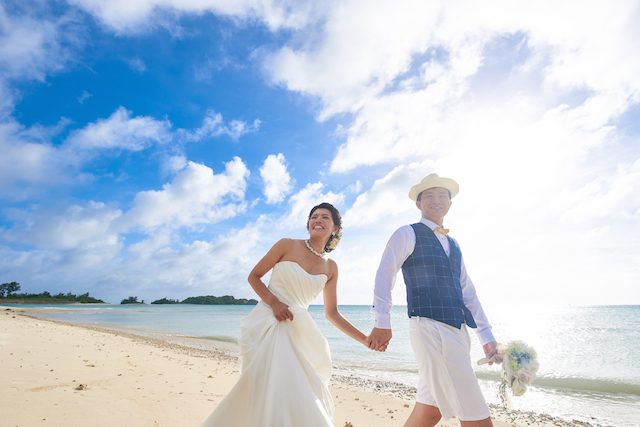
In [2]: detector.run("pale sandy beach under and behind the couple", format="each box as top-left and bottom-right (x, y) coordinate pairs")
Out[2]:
(0, 307), (575, 427)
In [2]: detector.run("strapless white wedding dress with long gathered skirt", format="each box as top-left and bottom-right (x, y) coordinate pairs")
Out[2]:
(202, 261), (334, 427)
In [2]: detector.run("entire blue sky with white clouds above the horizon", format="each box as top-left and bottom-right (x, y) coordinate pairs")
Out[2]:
(0, 0), (640, 307)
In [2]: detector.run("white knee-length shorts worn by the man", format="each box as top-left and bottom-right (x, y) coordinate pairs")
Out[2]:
(409, 317), (490, 421)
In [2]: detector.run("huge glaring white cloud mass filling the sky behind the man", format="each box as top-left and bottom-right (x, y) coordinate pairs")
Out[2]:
(264, 1), (640, 303)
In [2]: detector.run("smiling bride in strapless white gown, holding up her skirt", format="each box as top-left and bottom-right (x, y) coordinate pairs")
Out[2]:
(202, 203), (368, 427)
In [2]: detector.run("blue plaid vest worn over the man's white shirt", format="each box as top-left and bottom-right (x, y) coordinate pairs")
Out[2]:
(402, 223), (476, 329)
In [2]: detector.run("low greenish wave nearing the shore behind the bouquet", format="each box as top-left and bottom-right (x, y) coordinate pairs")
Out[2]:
(476, 372), (640, 396)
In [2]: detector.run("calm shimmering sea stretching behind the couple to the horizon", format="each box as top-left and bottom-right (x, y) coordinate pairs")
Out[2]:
(10, 304), (640, 427)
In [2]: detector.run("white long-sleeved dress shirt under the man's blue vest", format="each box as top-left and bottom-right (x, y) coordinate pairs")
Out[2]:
(373, 218), (495, 345)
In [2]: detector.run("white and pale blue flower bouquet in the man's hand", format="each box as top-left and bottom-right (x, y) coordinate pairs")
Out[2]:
(478, 341), (540, 423)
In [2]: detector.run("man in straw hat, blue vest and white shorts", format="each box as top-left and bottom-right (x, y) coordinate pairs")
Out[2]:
(369, 173), (500, 427)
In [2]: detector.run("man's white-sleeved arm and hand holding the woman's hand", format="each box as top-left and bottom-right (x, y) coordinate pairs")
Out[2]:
(369, 225), (416, 351)
